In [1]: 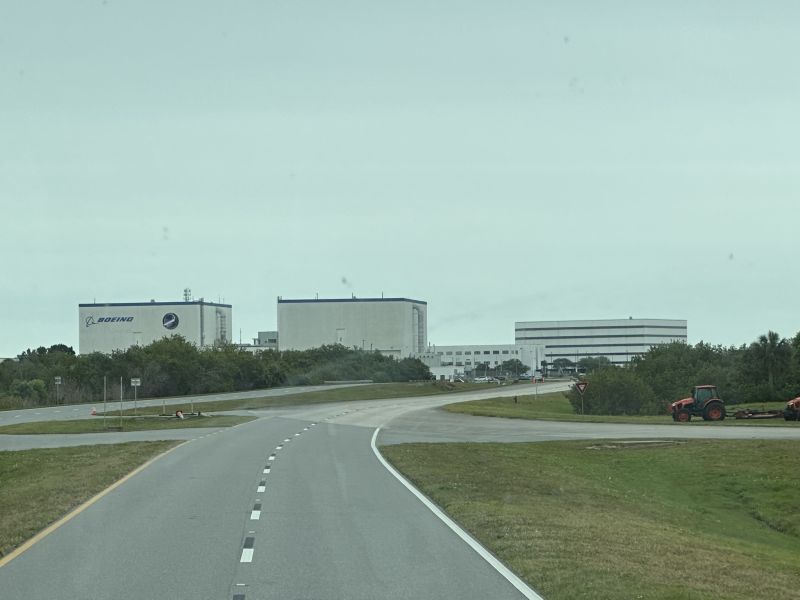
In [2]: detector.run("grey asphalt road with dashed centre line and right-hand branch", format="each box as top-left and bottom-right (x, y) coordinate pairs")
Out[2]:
(0, 384), (800, 600)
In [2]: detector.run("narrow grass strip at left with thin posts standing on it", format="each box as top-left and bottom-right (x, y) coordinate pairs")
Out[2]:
(0, 411), (255, 435)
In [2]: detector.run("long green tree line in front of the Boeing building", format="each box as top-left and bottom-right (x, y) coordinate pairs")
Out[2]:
(0, 336), (431, 406)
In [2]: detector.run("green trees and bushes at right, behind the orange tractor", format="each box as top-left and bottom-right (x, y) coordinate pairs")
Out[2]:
(569, 331), (800, 414)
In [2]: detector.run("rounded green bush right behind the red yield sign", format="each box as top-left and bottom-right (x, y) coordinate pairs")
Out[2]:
(568, 368), (664, 415)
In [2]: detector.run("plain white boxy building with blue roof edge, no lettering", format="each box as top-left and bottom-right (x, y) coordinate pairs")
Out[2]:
(278, 297), (428, 358)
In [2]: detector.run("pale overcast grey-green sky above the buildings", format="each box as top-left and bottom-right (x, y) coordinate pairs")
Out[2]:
(0, 0), (800, 357)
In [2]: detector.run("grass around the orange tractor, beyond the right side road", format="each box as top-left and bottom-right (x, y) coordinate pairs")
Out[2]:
(443, 392), (797, 427)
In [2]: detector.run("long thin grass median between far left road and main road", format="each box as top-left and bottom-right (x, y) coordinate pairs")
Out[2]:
(100, 382), (486, 415)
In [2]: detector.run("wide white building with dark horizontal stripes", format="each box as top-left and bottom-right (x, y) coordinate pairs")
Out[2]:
(514, 318), (687, 365)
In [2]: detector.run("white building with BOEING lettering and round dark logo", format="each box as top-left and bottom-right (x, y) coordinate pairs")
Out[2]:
(78, 300), (232, 354)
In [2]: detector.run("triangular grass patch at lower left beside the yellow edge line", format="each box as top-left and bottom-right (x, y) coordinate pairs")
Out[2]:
(0, 442), (178, 556)
